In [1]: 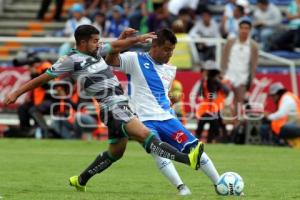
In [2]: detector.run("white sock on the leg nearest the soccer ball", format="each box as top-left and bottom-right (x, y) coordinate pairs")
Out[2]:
(200, 152), (219, 185)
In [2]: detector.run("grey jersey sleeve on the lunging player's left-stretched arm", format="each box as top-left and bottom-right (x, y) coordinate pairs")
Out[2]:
(46, 57), (74, 77)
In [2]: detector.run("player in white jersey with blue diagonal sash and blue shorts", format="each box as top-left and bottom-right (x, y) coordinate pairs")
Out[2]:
(106, 29), (219, 194)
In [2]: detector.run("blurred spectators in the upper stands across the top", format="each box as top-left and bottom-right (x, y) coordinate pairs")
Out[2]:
(41, 0), (300, 54)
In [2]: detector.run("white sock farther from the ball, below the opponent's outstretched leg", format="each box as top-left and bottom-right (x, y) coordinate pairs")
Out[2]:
(151, 154), (183, 188)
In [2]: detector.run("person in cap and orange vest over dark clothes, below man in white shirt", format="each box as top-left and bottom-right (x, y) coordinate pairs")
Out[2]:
(196, 60), (229, 143)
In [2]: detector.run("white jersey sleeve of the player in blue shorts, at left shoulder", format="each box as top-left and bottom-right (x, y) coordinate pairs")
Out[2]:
(120, 52), (137, 74)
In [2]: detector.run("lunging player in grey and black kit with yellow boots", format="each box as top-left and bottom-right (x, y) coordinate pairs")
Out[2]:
(4, 25), (203, 191)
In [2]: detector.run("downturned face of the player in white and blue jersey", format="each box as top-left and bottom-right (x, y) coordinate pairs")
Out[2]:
(152, 41), (175, 64)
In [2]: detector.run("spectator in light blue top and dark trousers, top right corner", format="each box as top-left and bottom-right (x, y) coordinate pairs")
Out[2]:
(272, 0), (300, 51)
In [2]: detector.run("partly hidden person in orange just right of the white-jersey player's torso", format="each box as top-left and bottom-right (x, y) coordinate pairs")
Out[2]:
(169, 80), (186, 125)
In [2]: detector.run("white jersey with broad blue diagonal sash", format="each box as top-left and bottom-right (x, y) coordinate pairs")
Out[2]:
(120, 52), (176, 121)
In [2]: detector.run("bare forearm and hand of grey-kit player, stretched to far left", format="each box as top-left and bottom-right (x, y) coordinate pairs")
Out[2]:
(3, 74), (54, 105)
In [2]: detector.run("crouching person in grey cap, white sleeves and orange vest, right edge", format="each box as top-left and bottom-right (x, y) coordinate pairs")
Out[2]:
(261, 82), (300, 144)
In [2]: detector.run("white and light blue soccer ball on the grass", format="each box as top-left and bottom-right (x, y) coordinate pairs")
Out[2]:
(216, 172), (244, 196)
